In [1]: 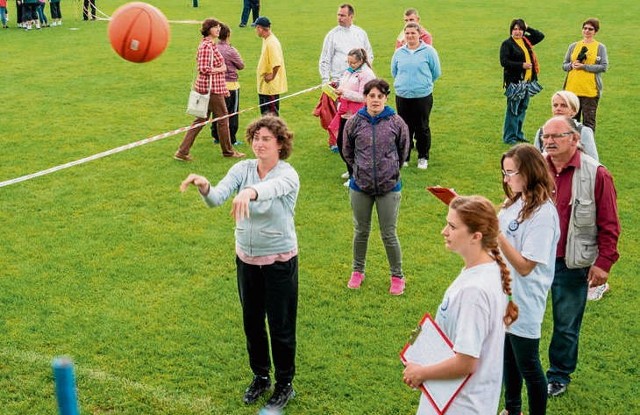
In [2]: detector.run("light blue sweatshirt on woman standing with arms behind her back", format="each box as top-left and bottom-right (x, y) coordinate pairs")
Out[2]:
(391, 41), (442, 98)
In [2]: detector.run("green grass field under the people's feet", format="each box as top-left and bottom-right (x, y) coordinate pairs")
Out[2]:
(0, 0), (640, 415)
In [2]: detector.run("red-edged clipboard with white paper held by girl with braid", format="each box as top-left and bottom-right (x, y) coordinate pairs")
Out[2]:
(400, 313), (471, 415)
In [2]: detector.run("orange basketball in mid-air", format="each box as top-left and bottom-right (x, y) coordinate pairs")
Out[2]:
(108, 1), (169, 63)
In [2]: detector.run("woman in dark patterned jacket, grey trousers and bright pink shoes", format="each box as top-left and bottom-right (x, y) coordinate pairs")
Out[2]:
(342, 79), (409, 295)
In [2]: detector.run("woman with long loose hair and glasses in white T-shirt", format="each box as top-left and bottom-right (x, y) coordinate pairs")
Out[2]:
(498, 144), (560, 415)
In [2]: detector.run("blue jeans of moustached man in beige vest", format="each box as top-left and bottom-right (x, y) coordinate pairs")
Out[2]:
(547, 258), (589, 384)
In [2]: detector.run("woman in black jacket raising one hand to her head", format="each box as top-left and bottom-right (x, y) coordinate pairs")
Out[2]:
(500, 19), (544, 144)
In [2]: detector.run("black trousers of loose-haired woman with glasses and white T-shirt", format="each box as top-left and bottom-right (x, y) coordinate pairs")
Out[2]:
(504, 333), (547, 415)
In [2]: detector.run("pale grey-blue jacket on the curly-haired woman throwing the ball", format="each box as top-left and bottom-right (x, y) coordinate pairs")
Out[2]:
(202, 160), (300, 256)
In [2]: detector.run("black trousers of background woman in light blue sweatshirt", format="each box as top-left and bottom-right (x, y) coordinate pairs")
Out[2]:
(396, 94), (433, 161)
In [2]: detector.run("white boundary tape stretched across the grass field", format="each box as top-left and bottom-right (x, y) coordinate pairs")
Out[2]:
(0, 84), (322, 188)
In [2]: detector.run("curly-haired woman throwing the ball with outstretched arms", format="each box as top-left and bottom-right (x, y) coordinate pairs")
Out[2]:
(180, 116), (300, 413)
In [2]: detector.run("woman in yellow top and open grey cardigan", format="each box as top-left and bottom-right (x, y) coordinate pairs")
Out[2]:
(562, 17), (609, 133)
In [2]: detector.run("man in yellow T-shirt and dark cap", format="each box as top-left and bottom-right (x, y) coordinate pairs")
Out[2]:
(254, 16), (287, 115)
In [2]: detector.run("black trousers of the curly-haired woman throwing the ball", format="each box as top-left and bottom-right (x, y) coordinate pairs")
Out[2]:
(236, 256), (298, 383)
